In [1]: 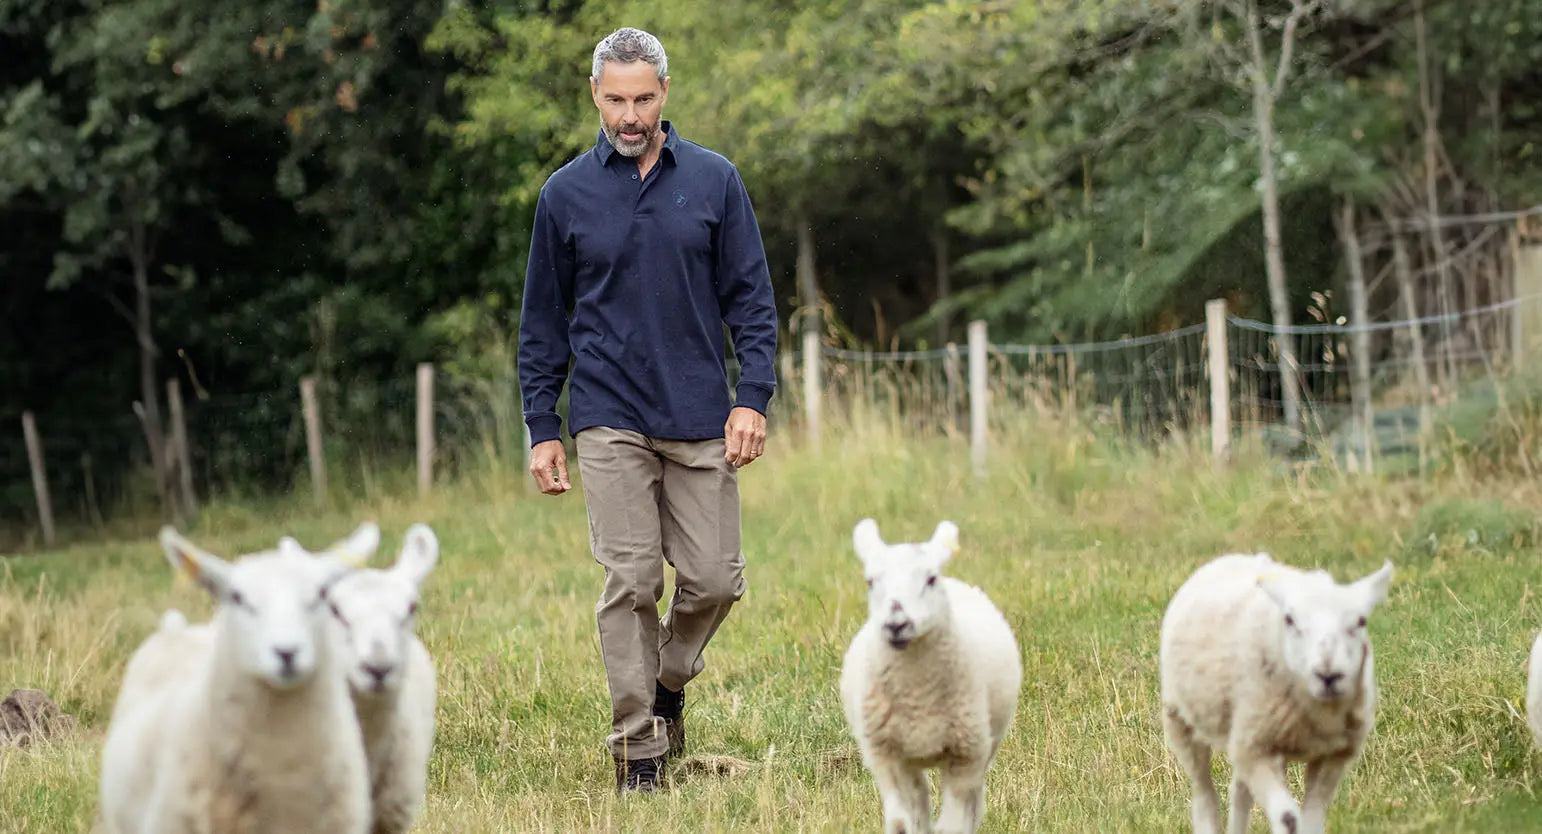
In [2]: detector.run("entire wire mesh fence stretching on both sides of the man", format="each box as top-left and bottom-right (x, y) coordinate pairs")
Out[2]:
(0, 296), (1542, 545)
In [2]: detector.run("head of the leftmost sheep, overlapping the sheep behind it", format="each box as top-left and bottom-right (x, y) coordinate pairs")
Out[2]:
(160, 527), (378, 689)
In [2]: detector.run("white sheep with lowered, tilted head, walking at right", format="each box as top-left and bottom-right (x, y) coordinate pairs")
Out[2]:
(1161, 553), (1392, 834)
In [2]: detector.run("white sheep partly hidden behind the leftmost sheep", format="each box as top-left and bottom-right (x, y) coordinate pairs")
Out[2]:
(328, 524), (439, 834)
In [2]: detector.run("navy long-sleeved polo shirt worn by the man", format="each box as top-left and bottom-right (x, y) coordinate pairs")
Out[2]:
(520, 122), (777, 444)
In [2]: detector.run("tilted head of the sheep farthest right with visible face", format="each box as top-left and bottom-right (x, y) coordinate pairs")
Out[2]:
(1258, 563), (1392, 701)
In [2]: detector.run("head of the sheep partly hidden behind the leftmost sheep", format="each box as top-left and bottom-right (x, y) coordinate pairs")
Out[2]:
(328, 524), (439, 695)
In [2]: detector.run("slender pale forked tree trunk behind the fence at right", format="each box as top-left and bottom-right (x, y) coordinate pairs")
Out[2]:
(1246, 2), (1301, 433)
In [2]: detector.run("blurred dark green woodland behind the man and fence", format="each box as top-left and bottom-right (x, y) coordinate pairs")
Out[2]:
(0, 0), (1542, 521)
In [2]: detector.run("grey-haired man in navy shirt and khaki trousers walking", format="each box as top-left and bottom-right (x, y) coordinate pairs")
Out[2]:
(520, 28), (777, 791)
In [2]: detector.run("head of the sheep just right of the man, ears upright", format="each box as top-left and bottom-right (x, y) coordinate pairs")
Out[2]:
(853, 518), (958, 649)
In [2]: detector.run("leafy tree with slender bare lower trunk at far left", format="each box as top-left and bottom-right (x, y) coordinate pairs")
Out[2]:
(0, 2), (239, 513)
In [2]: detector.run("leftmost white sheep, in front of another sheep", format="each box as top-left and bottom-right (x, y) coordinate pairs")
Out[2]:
(99, 524), (379, 834)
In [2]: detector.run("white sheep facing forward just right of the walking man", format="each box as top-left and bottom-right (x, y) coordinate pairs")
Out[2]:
(840, 518), (1022, 834)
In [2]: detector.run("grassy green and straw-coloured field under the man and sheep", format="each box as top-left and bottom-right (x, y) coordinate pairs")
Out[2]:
(0, 425), (1542, 834)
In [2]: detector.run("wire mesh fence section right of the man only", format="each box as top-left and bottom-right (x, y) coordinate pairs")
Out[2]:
(779, 296), (1542, 462)
